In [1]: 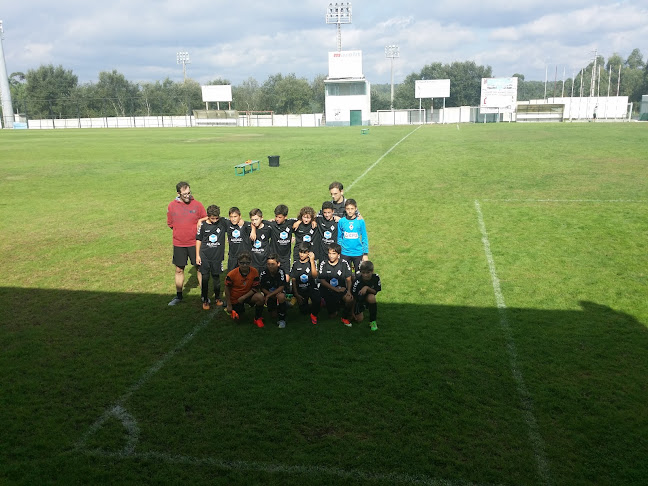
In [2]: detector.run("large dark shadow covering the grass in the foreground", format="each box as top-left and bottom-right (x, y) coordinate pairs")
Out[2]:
(0, 288), (648, 484)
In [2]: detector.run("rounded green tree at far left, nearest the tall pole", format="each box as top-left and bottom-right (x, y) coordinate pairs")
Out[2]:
(25, 64), (79, 118)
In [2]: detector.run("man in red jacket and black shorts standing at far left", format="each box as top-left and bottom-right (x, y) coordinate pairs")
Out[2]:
(167, 181), (207, 305)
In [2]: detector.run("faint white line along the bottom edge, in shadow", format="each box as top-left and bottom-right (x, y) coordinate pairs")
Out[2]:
(83, 449), (504, 486)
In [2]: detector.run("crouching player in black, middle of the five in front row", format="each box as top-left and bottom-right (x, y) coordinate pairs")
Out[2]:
(290, 242), (322, 324)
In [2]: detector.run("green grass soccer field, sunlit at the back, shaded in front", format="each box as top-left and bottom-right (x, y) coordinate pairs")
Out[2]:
(0, 123), (648, 486)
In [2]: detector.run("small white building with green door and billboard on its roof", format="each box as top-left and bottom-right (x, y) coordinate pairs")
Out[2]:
(324, 51), (371, 126)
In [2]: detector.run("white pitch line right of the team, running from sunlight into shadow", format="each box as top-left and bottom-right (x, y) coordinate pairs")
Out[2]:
(475, 200), (551, 485)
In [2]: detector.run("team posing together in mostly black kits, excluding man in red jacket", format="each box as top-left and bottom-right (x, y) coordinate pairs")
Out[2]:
(167, 182), (381, 331)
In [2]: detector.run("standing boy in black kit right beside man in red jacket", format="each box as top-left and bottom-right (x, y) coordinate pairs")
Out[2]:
(196, 204), (228, 310)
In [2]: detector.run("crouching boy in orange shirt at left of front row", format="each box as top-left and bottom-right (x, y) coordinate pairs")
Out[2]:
(225, 251), (264, 327)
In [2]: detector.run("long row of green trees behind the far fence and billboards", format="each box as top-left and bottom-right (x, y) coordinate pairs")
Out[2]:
(9, 49), (648, 118)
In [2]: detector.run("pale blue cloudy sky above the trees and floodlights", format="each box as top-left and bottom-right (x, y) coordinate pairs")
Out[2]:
(0, 0), (648, 84)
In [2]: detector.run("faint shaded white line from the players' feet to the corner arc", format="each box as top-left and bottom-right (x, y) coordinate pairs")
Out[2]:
(75, 312), (215, 455)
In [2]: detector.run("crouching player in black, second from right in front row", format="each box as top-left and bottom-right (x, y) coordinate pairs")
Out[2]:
(317, 243), (353, 327)
